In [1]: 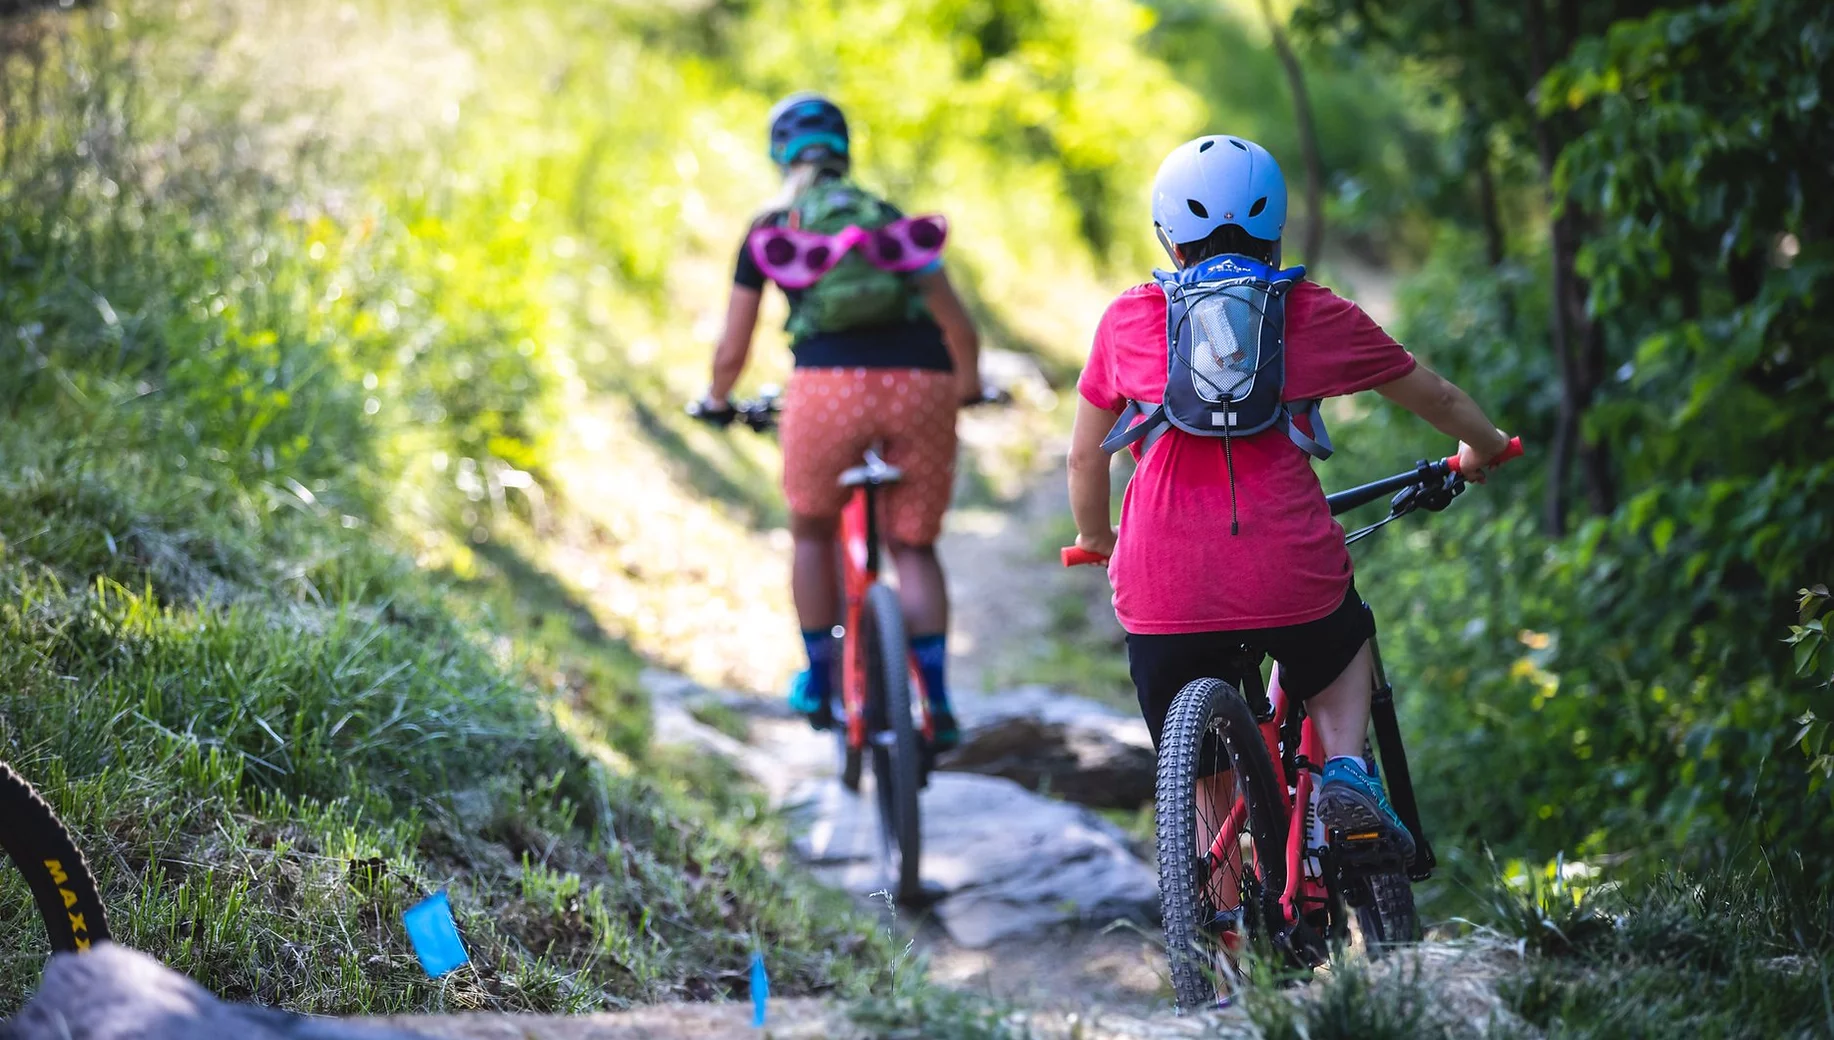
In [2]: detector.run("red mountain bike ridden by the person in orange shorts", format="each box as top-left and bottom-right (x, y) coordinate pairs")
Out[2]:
(690, 391), (1011, 902)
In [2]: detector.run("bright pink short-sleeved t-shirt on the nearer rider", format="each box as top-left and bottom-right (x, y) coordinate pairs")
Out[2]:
(1077, 282), (1414, 635)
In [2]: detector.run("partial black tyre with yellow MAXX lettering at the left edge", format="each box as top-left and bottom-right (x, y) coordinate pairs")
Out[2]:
(0, 763), (108, 954)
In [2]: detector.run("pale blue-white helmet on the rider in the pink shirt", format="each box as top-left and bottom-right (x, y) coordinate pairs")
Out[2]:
(1152, 134), (1286, 262)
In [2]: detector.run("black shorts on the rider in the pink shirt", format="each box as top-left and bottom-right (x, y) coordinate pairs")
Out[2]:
(1128, 583), (1376, 774)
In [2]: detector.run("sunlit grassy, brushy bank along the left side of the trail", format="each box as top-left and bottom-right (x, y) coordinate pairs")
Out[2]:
(0, 4), (889, 1012)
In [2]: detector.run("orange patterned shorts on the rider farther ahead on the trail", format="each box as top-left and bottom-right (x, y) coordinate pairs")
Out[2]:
(778, 369), (959, 545)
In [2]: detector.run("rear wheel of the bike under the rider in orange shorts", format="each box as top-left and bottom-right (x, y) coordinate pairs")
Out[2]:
(860, 583), (923, 902)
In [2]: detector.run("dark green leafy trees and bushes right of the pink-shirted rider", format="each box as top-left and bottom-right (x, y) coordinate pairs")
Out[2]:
(1300, 0), (1834, 887)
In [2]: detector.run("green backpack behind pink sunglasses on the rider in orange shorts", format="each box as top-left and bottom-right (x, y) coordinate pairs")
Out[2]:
(785, 178), (923, 339)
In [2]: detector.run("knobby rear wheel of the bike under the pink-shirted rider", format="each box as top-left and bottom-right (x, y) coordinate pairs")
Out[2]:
(1155, 679), (1286, 1011)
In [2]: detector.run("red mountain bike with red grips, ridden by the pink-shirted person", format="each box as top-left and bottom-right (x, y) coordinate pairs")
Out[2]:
(1064, 438), (1522, 1009)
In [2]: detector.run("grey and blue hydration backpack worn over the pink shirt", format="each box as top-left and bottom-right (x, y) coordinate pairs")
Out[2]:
(1102, 255), (1331, 459)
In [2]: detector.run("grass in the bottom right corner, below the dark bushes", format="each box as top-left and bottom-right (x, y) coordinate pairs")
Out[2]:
(1247, 860), (1834, 1040)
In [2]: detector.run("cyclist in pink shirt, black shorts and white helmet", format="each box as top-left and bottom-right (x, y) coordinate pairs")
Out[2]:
(1069, 136), (1509, 876)
